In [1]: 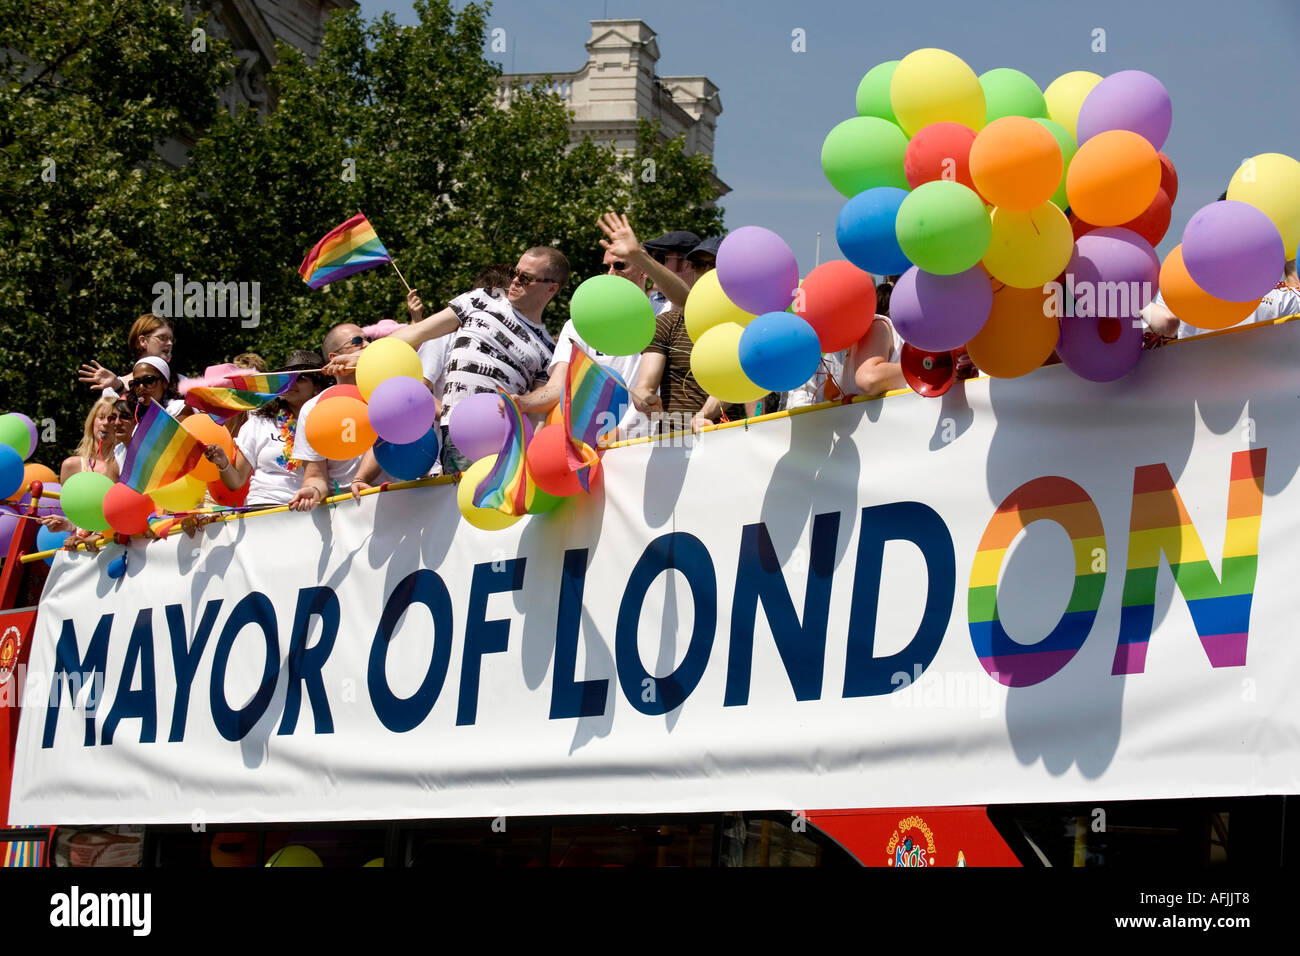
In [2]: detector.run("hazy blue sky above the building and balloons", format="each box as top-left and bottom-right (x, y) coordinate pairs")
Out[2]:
(360, 0), (1300, 272)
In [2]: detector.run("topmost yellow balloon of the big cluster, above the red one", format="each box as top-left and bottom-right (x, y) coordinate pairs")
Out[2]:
(889, 48), (985, 137)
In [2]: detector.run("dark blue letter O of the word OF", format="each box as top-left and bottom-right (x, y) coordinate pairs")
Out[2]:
(367, 568), (451, 734)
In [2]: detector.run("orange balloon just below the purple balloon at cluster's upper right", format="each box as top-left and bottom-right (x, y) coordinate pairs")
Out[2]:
(1065, 130), (1161, 226)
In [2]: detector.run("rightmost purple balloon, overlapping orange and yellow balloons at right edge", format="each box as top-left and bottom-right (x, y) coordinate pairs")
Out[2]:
(1183, 199), (1286, 302)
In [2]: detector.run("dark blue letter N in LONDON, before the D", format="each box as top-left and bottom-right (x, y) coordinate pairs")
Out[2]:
(723, 511), (840, 708)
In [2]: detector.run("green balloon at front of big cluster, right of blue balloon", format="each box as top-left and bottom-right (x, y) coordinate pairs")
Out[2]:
(894, 179), (993, 276)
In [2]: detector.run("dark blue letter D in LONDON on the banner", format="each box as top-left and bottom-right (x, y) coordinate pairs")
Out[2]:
(844, 501), (957, 697)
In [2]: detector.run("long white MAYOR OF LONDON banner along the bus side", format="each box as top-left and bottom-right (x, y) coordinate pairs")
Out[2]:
(10, 323), (1300, 823)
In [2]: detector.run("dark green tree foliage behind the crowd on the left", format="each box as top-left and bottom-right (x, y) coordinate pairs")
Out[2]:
(0, 0), (722, 458)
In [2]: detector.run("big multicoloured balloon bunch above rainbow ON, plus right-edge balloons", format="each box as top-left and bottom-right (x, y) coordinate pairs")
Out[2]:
(822, 49), (1300, 381)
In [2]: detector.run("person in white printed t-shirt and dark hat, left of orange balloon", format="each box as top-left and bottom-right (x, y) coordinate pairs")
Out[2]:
(204, 350), (328, 506)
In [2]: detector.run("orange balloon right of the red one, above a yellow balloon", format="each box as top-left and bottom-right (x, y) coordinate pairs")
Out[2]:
(970, 116), (1060, 209)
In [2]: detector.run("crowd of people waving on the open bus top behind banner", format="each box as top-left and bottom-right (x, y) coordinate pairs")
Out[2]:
(38, 213), (1300, 548)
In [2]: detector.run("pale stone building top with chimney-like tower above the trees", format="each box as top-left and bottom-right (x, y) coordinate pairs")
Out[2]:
(499, 20), (731, 196)
